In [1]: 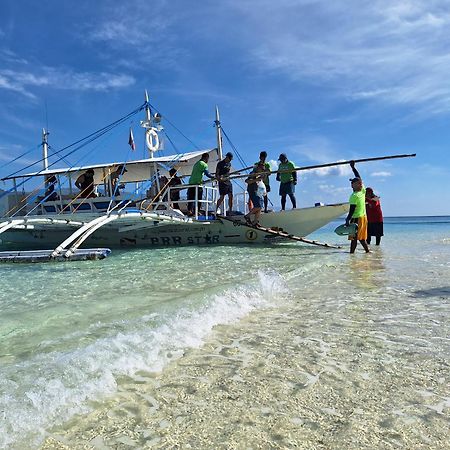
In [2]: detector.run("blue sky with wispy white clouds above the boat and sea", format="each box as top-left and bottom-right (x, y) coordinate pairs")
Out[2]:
(0, 0), (450, 216)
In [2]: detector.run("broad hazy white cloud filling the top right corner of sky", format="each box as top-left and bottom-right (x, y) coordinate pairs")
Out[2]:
(234, 0), (450, 114)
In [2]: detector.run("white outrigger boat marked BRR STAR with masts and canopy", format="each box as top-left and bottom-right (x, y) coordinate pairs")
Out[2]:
(0, 94), (356, 259)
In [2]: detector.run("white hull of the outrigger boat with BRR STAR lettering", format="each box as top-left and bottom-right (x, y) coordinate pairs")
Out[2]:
(0, 203), (348, 249)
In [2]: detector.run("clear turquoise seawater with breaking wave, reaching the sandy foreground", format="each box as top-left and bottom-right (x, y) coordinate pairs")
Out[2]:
(0, 217), (450, 449)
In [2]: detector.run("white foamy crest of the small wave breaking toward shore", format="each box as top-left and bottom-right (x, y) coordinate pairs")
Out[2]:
(0, 272), (287, 449)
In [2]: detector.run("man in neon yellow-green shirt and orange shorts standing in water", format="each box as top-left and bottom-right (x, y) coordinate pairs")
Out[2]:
(345, 161), (370, 253)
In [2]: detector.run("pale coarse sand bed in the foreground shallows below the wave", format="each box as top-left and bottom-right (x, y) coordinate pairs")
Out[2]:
(42, 301), (450, 450)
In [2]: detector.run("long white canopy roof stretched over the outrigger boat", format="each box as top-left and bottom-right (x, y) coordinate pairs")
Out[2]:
(2, 148), (219, 184)
